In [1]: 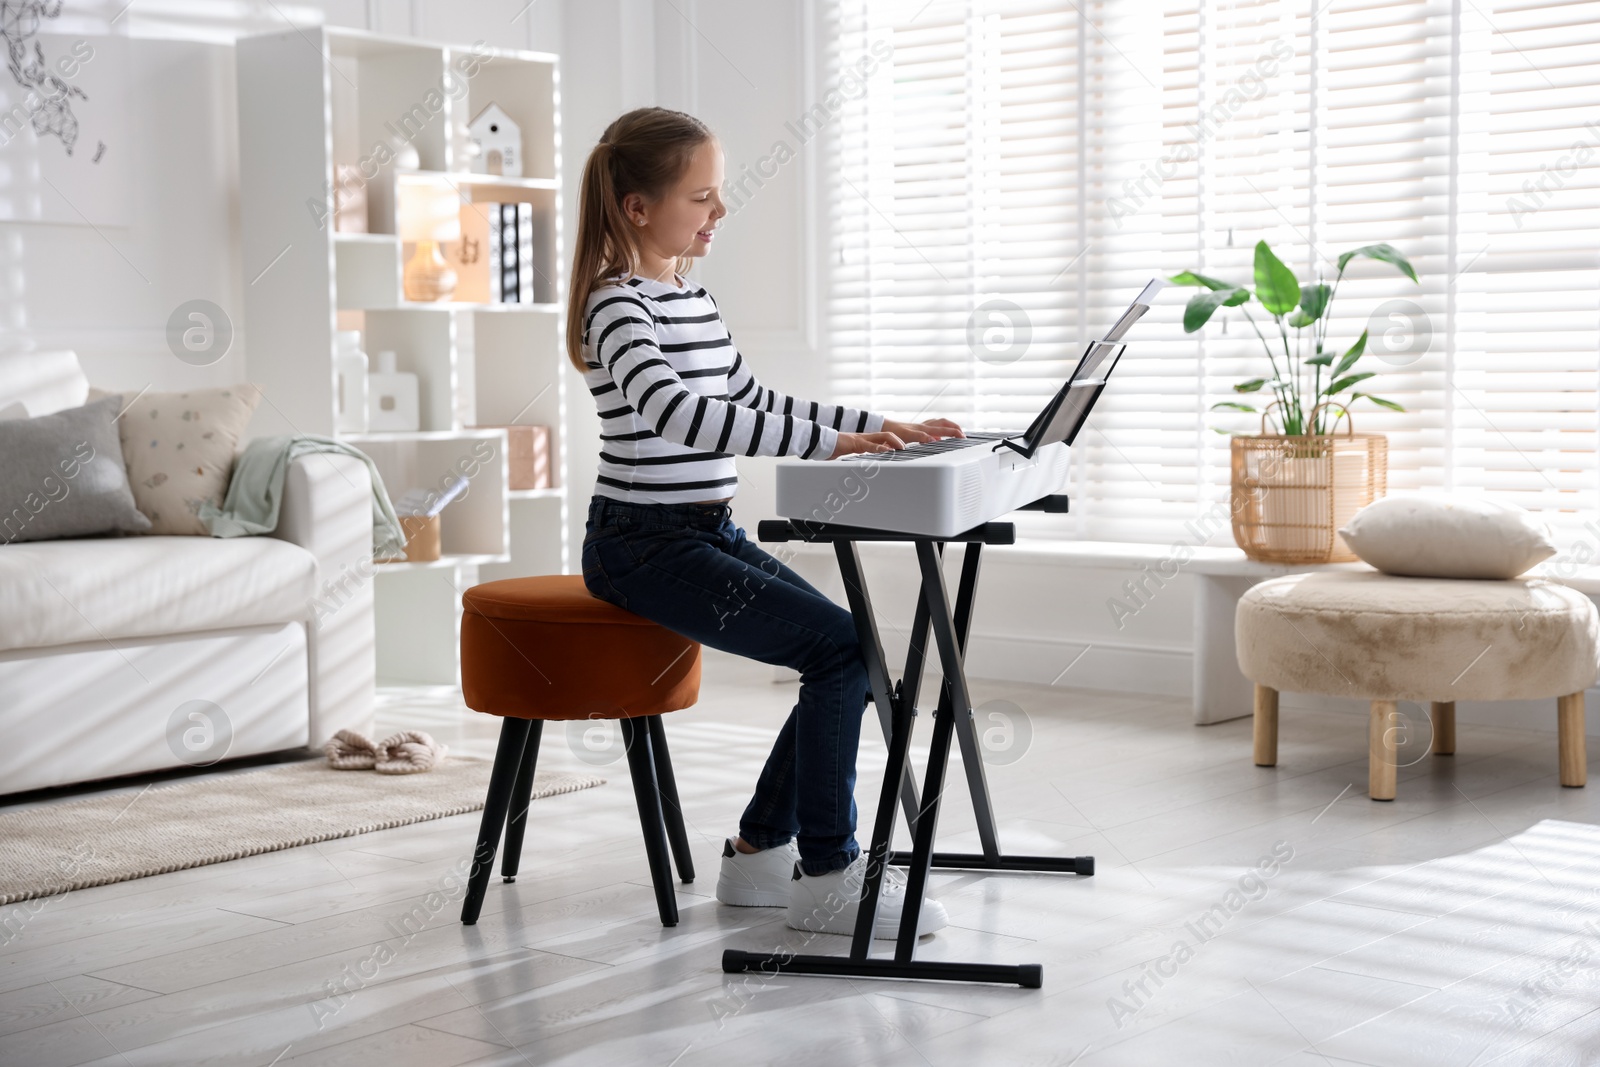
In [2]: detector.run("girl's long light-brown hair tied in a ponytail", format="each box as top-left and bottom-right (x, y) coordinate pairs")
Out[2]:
(566, 107), (715, 371)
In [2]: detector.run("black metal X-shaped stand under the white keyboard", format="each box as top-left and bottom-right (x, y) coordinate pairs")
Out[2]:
(722, 496), (1094, 989)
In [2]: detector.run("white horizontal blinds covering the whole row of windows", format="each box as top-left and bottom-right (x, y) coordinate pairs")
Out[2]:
(819, 0), (1600, 542)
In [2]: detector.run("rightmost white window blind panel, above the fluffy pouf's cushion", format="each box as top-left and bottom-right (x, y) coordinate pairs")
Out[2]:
(1448, 0), (1600, 521)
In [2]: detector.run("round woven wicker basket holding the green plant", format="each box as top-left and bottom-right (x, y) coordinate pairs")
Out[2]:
(1232, 404), (1389, 563)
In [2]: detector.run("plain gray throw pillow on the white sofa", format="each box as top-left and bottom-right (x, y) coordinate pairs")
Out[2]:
(0, 394), (150, 544)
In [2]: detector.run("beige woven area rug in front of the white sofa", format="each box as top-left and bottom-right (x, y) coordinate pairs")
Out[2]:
(0, 757), (605, 904)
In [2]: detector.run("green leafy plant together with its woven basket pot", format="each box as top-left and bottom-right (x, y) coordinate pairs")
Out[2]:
(1171, 242), (1418, 563)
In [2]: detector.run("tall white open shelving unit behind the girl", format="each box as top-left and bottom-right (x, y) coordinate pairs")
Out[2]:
(237, 27), (570, 685)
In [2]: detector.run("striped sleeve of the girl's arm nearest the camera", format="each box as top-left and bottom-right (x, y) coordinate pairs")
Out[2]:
(586, 294), (840, 459)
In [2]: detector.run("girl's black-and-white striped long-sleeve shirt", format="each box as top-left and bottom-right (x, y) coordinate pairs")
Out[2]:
(584, 275), (883, 504)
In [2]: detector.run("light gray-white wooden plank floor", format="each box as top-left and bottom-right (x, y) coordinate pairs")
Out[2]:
(0, 656), (1600, 1067)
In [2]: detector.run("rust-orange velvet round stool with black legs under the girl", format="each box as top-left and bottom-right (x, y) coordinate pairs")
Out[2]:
(461, 574), (701, 926)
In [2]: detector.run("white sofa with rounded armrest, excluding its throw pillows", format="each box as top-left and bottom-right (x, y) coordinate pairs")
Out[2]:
(0, 352), (374, 793)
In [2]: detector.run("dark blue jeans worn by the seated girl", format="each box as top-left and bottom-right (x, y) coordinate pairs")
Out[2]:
(582, 496), (869, 875)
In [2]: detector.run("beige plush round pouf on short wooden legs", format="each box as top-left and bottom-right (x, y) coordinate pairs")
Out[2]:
(1234, 571), (1600, 800)
